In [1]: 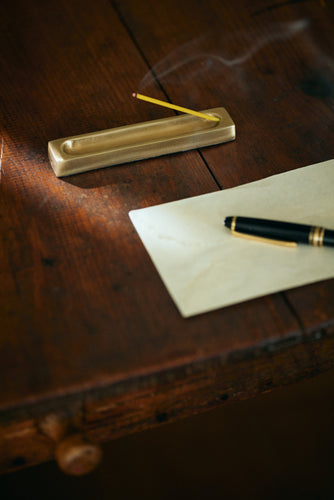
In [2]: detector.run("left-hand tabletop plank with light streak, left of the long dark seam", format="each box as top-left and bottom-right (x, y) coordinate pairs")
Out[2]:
(1, 2), (298, 414)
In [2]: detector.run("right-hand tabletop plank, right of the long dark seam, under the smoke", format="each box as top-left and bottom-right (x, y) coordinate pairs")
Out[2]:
(114, 0), (334, 356)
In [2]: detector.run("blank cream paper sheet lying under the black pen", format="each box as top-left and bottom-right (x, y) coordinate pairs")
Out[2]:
(129, 160), (334, 317)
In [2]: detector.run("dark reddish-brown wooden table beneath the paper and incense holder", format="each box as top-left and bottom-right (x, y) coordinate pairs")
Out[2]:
(0, 0), (334, 471)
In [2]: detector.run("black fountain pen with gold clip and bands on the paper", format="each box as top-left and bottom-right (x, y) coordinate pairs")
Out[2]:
(224, 216), (334, 247)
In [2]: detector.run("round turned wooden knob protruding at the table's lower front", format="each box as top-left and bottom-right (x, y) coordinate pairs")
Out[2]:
(55, 434), (102, 476)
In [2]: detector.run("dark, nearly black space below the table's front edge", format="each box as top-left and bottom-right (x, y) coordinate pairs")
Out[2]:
(0, 370), (334, 500)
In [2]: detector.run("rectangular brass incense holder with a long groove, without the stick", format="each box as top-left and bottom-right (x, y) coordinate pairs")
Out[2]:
(48, 108), (235, 177)
